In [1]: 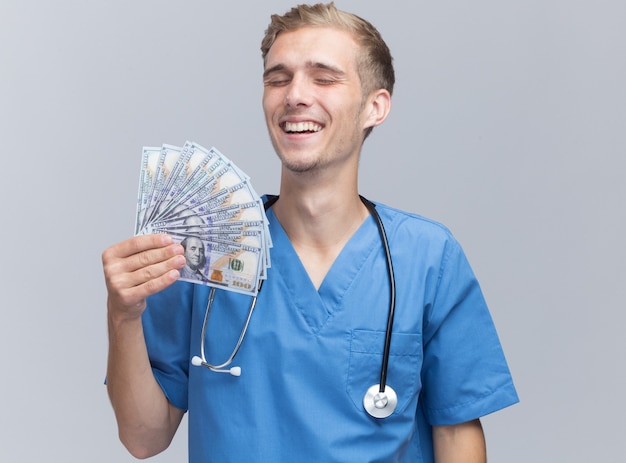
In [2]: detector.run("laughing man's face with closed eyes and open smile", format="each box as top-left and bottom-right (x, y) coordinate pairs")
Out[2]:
(263, 27), (367, 176)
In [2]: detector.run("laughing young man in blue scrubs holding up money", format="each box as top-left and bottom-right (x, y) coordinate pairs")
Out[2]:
(103, 4), (517, 463)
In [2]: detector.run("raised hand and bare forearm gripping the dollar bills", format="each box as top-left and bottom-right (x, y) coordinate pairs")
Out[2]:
(102, 234), (185, 458)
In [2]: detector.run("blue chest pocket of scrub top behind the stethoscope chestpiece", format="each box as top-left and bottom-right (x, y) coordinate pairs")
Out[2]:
(346, 330), (422, 416)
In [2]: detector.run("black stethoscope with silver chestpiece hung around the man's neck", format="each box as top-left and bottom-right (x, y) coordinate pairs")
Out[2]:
(191, 196), (398, 418)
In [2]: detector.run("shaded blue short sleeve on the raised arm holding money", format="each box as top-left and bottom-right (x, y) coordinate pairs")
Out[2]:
(143, 281), (193, 410)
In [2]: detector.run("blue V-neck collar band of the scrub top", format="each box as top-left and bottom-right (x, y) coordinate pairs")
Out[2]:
(267, 209), (380, 332)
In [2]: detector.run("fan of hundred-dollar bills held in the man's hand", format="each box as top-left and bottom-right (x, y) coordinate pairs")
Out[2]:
(135, 142), (272, 295)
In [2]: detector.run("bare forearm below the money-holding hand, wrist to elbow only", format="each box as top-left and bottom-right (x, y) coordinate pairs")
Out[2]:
(107, 312), (183, 458)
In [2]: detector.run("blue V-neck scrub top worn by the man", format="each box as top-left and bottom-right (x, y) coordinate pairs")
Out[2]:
(144, 204), (518, 463)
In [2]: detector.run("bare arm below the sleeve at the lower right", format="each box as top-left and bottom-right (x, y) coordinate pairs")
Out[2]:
(433, 420), (487, 463)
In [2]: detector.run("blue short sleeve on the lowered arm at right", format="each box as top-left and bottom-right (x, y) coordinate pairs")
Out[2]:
(420, 239), (519, 426)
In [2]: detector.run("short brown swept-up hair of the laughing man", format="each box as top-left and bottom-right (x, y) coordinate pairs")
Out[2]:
(261, 2), (395, 97)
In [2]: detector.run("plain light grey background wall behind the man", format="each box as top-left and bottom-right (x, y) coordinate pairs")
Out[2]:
(0, 0), (626, 463)
